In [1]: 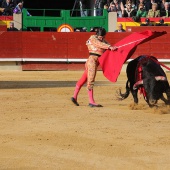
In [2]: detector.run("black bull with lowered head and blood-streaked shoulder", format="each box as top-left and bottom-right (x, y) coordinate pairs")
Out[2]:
(118, 55), (170, 107)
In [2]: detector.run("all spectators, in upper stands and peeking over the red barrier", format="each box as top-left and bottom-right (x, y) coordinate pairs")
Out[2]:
(0, 0), (170, 32)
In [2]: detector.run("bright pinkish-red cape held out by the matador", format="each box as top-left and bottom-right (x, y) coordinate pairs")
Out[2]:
(99, 30), (165, 82)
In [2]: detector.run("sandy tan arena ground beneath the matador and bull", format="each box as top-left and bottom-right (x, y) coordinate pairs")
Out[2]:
(0, 71), (170, 170)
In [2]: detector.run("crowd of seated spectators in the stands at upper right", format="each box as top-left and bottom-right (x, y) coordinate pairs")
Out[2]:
(105, 0), (170, 21)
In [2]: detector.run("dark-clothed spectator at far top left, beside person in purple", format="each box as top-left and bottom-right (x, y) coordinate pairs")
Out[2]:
(2, 0), (14, 16)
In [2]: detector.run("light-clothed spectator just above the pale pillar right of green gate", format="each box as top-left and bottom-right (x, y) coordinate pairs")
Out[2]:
(108, 0), (124, 18)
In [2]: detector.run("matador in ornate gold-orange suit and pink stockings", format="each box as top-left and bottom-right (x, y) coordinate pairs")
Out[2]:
(71, 28), (116, 107)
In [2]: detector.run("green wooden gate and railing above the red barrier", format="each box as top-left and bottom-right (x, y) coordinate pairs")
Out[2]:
(22, 9), (108, 32)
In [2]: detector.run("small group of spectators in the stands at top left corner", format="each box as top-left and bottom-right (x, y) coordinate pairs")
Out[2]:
(0, 0), (30, 16)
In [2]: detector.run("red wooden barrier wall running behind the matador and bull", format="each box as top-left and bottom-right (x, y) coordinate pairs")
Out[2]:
(0, 27), (170, 70)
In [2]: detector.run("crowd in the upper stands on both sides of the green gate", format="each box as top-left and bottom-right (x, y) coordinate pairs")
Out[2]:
(0, 0), (170, 20)
